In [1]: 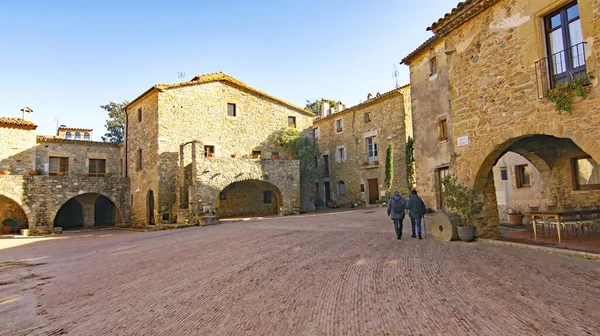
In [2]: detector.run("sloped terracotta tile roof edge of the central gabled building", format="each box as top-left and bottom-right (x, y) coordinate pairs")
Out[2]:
(125, 72), (314, 116)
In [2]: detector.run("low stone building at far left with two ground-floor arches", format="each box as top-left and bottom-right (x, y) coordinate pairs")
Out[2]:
(0, 108), (129, 234)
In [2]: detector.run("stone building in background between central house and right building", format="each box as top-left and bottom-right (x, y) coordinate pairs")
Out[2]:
(312, 85), (410, 205)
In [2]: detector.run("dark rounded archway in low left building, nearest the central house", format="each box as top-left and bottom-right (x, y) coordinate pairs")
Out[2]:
(54, 193), (122, 230)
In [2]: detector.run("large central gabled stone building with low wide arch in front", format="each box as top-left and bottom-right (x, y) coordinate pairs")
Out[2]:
(125, 73), (314, 225)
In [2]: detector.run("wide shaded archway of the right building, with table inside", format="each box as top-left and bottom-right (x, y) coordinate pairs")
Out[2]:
(474, 134), (600, 236)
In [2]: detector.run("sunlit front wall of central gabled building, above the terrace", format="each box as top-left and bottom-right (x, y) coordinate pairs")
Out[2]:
(155, 82), (312, 218)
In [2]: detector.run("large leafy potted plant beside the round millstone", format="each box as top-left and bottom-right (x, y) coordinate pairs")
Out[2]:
(442, 175), (481, 242)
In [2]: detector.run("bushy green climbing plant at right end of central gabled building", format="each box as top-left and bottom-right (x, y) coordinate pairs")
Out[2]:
(275, 128), (321, 179)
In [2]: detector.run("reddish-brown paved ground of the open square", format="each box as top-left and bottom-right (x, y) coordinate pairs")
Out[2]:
(0, 209), (600, 335)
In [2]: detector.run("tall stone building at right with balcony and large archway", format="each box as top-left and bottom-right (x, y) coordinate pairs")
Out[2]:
(403, 0), (600, 236)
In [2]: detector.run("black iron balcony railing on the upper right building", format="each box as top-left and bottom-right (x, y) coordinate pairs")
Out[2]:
(535, 42), (587, 98)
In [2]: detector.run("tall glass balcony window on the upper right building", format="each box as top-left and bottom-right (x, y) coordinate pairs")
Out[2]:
(545, 3), (586, 86)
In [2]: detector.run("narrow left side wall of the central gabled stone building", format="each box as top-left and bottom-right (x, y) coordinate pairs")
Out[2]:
(126, 92), (159, 226)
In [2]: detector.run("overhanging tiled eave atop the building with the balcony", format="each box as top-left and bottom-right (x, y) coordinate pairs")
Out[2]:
(427, 0), (499, 35)
